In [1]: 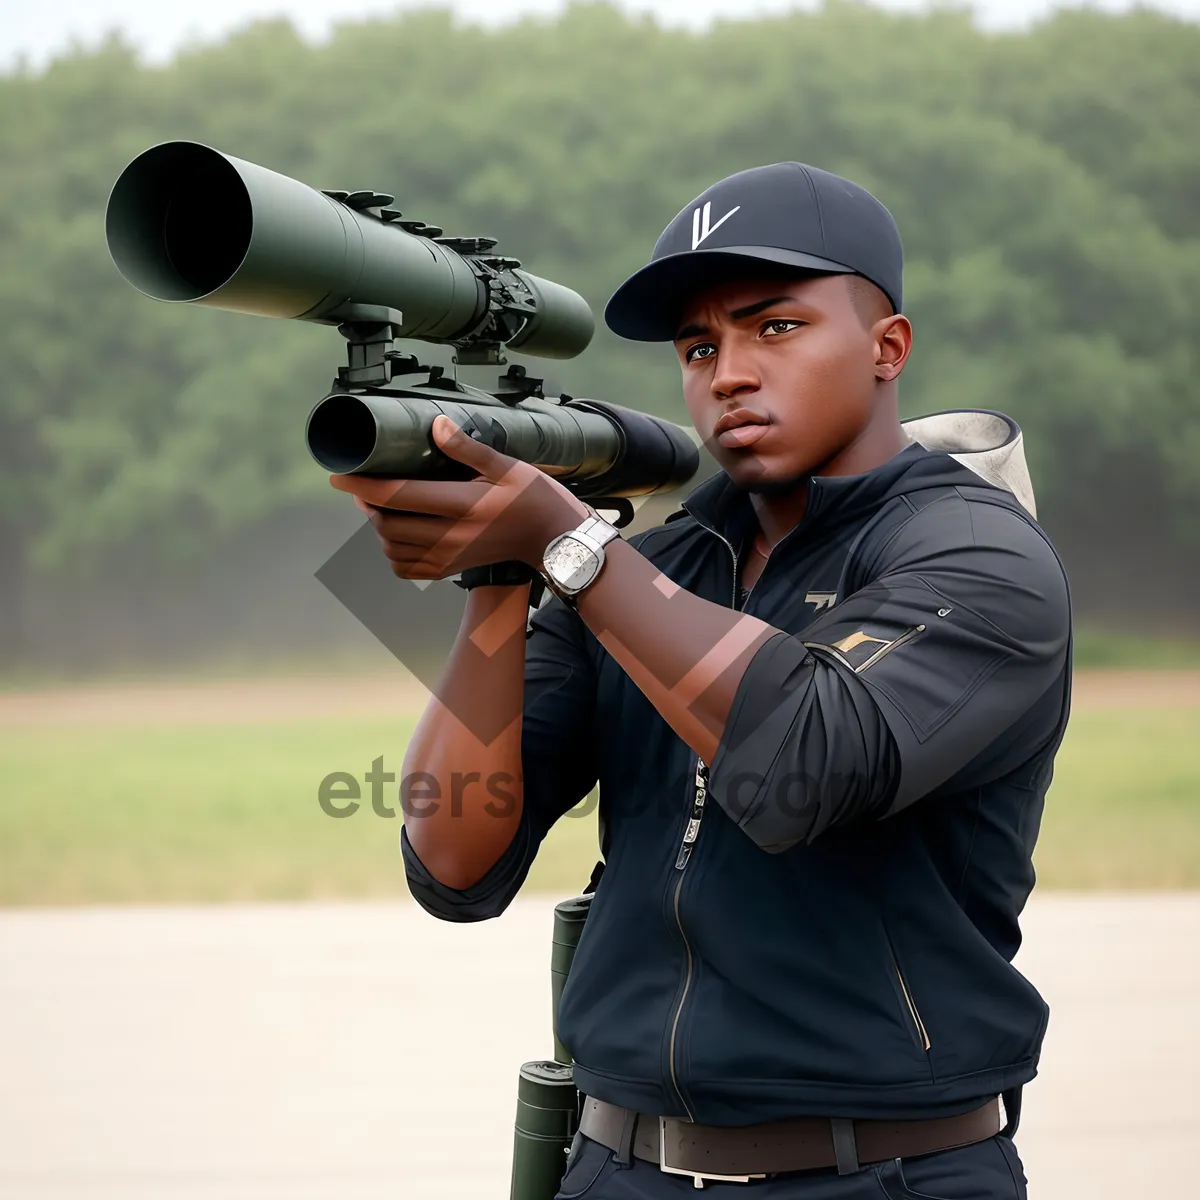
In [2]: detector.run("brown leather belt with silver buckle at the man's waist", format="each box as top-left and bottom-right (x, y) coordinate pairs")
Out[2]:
(580, 1096), (1001, 1188)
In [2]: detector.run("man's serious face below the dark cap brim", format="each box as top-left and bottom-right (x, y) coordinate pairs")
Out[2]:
(674, 275), (880, 492)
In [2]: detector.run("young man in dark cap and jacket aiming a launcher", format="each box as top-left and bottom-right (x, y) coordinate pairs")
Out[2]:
(334, 163), (1070, 1200)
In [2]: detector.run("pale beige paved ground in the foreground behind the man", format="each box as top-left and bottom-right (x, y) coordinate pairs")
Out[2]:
(0, 894), (1200, 1200)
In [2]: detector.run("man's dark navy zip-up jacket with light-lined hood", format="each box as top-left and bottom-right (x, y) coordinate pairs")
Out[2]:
(401, 414), (1070, 1124)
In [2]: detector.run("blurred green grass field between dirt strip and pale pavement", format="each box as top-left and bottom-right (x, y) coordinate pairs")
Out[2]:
(0, 707), (1200, 905)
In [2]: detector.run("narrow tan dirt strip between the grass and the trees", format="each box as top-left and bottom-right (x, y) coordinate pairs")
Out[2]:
(0, 667), (1200, 728)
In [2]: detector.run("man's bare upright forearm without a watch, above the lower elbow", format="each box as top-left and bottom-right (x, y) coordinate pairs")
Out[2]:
(402, 584), (529, 888)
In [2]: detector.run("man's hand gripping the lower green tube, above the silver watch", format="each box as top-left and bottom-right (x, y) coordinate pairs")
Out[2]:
(329, 416), (589, 580)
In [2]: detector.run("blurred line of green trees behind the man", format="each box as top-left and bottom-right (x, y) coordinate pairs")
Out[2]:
(0, 0), (1200, 662)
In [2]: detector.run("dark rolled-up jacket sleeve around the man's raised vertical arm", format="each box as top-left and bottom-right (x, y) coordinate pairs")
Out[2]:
(400, 596), (599, 922)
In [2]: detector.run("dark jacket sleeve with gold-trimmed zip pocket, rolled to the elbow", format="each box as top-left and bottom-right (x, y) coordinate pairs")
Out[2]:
(709, 494), (1070, 852)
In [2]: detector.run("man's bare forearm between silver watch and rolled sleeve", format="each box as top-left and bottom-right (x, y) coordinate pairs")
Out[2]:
(578, 541), (780, 763)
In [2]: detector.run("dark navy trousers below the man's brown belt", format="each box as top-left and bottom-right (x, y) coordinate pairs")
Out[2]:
(554, 1135), (1026, 1200)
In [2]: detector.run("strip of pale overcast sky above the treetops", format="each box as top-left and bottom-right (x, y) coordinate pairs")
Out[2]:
(0, 0), (1200, 70)
